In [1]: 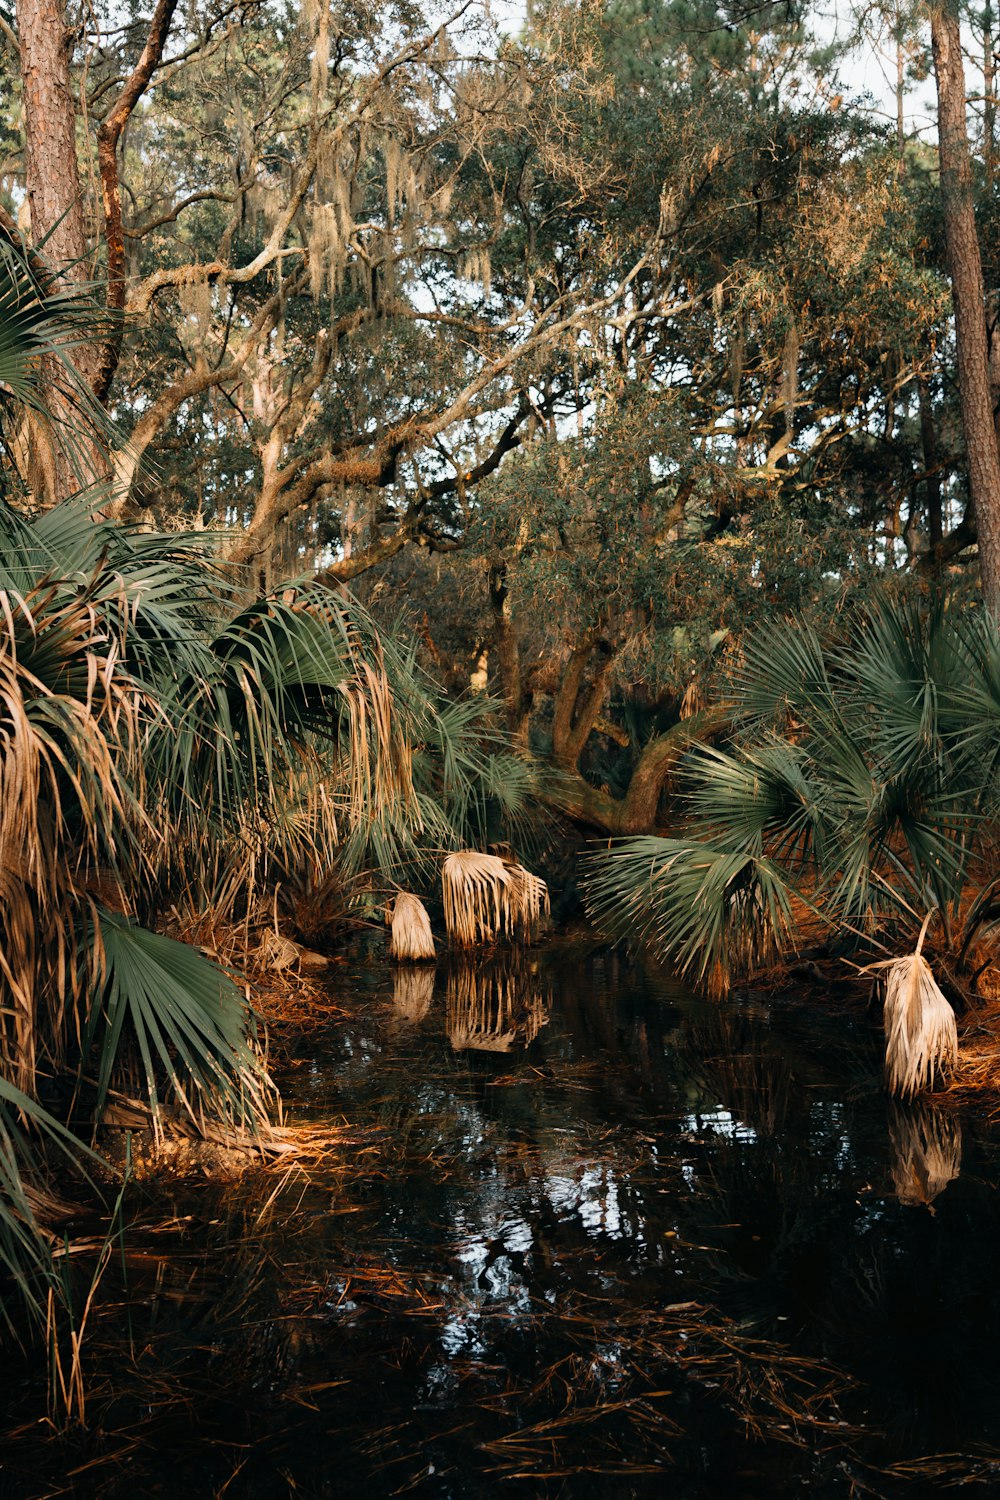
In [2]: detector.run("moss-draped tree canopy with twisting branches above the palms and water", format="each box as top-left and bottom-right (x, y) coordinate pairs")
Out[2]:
(0, 0), (1000, 825)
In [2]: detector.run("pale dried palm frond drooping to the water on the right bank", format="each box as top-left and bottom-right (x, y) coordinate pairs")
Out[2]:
(865, 912), (958, 1100)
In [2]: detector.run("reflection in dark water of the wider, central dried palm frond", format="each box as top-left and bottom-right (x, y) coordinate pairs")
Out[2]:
(447, 963), (552, 1052)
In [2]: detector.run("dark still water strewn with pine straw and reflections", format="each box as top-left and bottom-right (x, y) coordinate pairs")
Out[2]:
(0, 953), (1000, 1500)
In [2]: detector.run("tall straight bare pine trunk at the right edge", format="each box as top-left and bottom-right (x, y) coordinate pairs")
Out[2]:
(931, 0), (1000, 614)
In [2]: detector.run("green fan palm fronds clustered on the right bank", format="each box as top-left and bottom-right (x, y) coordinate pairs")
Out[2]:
(591, 597), (1000, 990)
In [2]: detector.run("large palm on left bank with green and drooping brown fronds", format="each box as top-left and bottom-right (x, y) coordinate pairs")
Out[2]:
(0, 237), (536, 1338)
